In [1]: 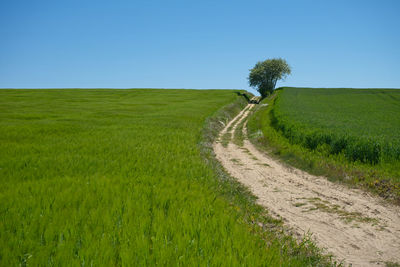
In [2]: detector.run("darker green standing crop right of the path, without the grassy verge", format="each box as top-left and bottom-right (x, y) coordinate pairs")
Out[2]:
(274, 88), (400, 164)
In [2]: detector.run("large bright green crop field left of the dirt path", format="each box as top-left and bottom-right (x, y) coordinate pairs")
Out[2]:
(0, 89), (320, 266)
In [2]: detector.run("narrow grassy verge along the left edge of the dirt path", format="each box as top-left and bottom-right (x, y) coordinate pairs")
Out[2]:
(199, 91), (334, 266)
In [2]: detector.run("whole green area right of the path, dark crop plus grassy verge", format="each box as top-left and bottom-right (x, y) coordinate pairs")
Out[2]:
(248, 88), (400, 203)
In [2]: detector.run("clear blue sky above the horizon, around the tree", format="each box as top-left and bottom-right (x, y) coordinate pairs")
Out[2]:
(0, 0), (400, 94)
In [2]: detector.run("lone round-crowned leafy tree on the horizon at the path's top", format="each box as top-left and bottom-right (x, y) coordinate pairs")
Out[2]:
(249, 58), (291, 98)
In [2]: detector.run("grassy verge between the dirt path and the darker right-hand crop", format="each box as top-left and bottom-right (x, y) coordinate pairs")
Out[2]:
(247, 90), (400, 205)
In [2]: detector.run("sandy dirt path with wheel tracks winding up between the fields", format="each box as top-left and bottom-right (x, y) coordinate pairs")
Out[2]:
(214, 104), (400, 266)
